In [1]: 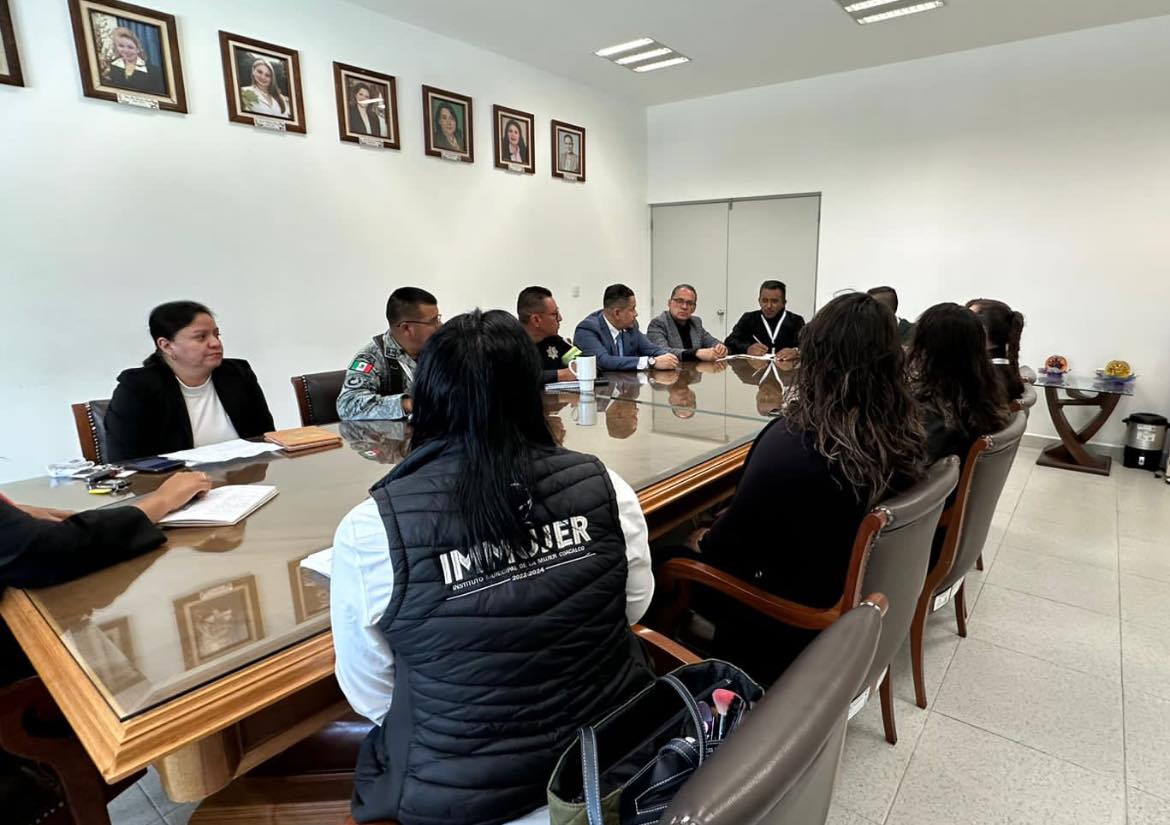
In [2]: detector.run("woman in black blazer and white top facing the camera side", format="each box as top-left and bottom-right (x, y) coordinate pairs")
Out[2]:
(105, 301), (276, 461)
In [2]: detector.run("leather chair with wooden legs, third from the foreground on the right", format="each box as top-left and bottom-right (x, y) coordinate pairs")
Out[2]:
(910, 411), (1027, 708)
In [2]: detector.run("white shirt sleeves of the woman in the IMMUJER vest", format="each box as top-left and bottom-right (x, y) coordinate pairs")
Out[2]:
(329, 469), (654, 724)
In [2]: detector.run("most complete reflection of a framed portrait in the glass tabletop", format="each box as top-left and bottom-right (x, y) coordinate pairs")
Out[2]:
(174, 576), (264, 669)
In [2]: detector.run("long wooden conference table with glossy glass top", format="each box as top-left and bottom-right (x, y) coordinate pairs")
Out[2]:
(0, 362), (784, 819)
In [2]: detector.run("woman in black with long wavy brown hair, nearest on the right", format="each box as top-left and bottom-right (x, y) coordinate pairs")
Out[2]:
(698, 293), (925, 607)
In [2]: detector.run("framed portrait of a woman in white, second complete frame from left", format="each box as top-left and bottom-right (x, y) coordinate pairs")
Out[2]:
(220, 32), (304, 135)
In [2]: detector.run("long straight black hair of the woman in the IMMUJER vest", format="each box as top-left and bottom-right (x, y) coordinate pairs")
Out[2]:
(411, 309), (556, 548)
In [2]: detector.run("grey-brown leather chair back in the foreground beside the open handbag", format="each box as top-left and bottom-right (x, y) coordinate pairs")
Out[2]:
(659, 594), (886, 825)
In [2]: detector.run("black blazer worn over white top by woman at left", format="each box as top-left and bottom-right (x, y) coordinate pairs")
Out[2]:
(105, 358), (276, 461)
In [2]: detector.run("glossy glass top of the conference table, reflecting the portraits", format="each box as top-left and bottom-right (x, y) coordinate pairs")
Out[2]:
(4, 407), (772, 719)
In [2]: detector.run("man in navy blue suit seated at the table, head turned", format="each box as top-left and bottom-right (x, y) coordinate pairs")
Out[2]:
(573, 283), (679, 370)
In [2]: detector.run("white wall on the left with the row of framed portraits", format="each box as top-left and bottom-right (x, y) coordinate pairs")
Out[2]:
(0, 0), (649, 480)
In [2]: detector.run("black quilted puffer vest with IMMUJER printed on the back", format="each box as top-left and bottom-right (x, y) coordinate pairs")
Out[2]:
(353, 442), (652, 825)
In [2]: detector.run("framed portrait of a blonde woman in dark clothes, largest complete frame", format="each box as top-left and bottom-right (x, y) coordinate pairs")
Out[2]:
(69, 0), (187, 114)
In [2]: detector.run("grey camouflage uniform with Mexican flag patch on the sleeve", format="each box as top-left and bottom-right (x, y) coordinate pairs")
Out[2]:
(337, 331), (418, 421)
